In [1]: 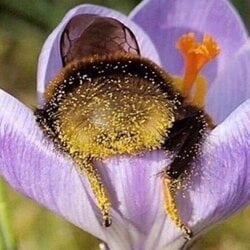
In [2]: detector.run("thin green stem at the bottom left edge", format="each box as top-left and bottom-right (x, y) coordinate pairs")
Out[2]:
(0, 178), (17, 250)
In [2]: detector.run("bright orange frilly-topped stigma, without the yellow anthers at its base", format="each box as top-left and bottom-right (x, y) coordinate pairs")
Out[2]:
(176, 33), (220, 97)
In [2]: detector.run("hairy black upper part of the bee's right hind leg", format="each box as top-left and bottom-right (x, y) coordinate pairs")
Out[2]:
(163, 105), (209, 179)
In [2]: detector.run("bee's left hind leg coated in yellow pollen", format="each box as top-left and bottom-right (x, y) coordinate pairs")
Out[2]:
(73, 156), (112, 227)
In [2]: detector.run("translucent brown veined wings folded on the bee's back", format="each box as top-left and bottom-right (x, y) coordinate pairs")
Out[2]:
(60, 14), (140, 65)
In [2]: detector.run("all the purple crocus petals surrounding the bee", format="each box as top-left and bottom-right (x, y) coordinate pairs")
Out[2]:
(0, 0), (250, 250)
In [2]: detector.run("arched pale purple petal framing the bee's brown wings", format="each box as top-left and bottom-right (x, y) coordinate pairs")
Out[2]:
(37, 4), (159, 103)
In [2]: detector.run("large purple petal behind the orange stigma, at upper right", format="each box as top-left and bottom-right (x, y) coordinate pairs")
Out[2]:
(130, 0), (247, 82)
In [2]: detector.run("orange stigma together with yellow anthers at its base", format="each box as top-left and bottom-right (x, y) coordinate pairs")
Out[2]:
(174, 33), (220, 107)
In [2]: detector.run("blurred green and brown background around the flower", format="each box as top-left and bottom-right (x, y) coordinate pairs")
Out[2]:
(0, 0), (250, 250)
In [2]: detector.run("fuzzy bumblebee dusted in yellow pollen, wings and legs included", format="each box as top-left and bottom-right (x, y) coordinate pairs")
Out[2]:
(35, 14), (219, 238)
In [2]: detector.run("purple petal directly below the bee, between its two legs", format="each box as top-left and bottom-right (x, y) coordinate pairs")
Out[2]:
(98, 152), (175, 250)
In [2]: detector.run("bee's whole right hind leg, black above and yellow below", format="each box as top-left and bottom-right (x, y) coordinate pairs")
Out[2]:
(162, 107), (208, 239)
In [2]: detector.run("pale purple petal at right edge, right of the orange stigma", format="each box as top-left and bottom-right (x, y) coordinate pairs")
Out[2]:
(206, 43), (250, 124)
